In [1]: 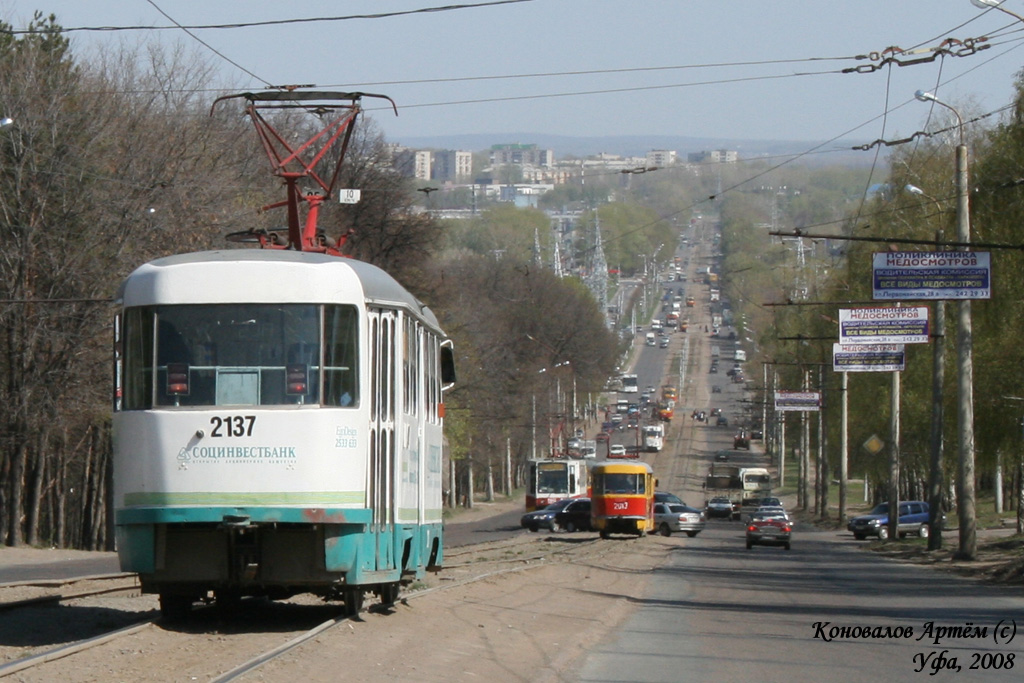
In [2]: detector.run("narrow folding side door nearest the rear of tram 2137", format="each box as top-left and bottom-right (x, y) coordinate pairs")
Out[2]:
(367, 310), (398, 569)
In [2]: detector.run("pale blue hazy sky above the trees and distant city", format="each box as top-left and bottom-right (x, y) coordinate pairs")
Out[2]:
(0, 0), (1024, 152)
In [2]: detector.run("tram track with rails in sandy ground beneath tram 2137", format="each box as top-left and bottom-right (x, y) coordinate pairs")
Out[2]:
(0, 533), (614, 682)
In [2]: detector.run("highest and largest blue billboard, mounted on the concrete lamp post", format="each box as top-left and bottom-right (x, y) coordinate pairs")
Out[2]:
(871, 251), (992, 300)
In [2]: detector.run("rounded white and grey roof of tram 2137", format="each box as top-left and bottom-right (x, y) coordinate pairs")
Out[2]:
(118, 249), (437, 328)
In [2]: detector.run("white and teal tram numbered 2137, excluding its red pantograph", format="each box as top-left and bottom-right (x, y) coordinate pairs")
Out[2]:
(114, 250), (455, 615)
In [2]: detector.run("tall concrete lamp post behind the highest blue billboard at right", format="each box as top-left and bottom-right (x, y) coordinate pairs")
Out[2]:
(913, 89), (980, 560)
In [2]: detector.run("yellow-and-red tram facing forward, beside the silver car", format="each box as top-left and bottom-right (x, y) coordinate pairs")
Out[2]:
(590, 462), (654, 539)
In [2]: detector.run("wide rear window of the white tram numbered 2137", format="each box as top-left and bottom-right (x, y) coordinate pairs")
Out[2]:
(123, 304), (358, 410)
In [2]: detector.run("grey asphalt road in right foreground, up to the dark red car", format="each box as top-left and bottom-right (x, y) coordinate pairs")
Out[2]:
(581, 521), (1024, 683)
